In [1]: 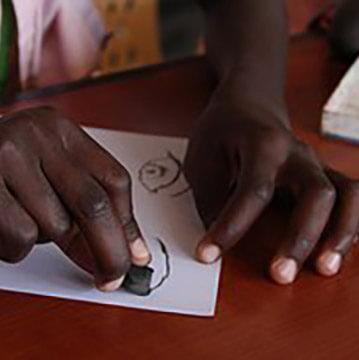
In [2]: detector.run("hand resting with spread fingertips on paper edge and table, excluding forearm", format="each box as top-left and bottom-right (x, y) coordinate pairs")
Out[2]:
(185, 103), (359, 284)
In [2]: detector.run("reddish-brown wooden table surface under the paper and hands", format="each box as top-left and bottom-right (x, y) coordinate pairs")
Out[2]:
(0, 37), (359, 360)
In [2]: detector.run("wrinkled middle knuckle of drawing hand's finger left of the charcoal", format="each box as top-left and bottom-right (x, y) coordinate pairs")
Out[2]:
(77, 185), (112, 220)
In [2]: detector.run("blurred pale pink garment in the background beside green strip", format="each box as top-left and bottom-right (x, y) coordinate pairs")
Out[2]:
(13, 0), (106, 88)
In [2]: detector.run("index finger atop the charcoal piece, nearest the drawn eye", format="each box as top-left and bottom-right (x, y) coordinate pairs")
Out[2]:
(72, 134), (151, 266)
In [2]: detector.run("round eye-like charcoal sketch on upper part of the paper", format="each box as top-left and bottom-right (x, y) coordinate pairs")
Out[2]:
(138, 151), (190, 197)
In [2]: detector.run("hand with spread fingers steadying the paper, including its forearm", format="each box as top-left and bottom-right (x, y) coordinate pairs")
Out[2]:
(185, 0), (359, 284)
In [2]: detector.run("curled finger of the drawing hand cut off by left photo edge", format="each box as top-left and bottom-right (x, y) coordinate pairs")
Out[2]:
(0, 179), (38, 263)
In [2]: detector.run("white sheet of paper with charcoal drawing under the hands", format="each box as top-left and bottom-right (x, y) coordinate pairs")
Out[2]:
(0, 129), (221, 316)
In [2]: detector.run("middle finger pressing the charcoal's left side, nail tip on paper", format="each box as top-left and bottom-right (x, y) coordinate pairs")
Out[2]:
(43, 154), (130, 291)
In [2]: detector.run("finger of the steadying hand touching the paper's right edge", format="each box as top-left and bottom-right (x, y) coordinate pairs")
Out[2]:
(197, 158), (277, 263)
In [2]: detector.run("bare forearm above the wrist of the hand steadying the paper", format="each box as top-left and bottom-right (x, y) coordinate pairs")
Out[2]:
(200, 0), (288, 122)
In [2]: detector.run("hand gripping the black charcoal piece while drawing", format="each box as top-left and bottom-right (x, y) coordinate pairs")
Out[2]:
(0, 108), (150, 291)
